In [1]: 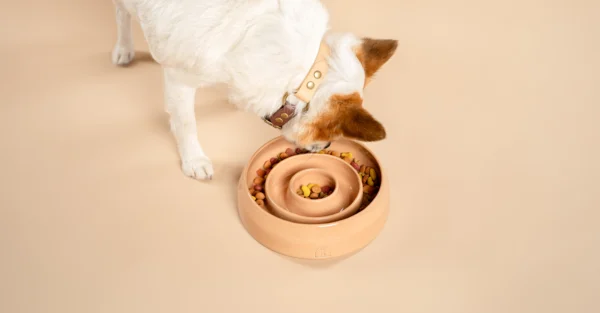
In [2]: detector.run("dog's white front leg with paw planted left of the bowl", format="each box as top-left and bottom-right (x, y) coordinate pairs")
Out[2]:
(164, 69), (213, 179)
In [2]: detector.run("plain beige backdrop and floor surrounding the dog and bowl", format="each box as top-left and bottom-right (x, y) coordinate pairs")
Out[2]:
(0, 0), (600, 313)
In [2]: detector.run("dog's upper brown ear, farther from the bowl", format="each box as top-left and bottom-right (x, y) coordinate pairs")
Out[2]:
(356, 38), (398, 85)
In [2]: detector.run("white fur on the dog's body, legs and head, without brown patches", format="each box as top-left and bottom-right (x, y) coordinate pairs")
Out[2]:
(112, 0), (365, 179)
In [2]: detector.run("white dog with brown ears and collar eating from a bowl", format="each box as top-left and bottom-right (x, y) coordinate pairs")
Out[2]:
(112, 0), (398, 180)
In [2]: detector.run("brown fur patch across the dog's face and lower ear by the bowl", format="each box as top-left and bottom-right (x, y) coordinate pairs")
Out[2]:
(299, 92), (386, 142)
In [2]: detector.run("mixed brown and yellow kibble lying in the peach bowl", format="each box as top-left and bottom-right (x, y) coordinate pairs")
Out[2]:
(248, 148), (380, 211)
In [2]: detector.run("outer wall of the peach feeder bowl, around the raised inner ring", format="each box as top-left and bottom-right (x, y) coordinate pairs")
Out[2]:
(238, 137), (390, 259)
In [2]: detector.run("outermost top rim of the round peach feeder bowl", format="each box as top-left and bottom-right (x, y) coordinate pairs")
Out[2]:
(238, 135), (388, 227)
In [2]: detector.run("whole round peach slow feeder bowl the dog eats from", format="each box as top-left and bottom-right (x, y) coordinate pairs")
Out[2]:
(238, 137), (389, 259)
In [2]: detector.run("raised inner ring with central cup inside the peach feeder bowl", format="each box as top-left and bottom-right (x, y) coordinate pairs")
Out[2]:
(265, 154), (363, 224)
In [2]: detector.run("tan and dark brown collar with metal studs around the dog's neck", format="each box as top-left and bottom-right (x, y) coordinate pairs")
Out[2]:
(263, 42), (330, 129)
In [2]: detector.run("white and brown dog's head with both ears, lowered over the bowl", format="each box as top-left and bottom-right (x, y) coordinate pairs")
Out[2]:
(282, 34), (398, 151)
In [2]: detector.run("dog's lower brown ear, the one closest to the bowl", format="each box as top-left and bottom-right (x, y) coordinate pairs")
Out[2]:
(341, 106), (386, 141)
